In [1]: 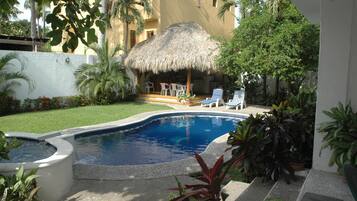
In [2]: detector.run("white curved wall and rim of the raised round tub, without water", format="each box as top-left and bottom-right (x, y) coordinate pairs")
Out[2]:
(0, 133), (73, 201)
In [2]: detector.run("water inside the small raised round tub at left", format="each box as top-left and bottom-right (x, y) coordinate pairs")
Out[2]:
(0, 139), (56, 163)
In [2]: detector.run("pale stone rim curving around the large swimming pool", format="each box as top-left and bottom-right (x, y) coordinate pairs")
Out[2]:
(60, 110), (248, 180)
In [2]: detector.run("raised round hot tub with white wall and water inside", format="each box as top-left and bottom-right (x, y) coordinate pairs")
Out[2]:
(0, 133), (73, 201)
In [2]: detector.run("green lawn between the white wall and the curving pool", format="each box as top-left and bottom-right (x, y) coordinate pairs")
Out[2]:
(0, 102), (171, 133)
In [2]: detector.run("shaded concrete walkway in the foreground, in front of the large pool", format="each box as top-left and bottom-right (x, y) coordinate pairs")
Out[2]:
(65, 176), (197, 201)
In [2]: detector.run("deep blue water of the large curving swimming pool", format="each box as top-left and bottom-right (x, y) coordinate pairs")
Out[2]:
(74, 114), (240, 165)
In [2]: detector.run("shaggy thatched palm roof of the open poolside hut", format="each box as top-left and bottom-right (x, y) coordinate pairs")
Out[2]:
(125, 22), (219, 73)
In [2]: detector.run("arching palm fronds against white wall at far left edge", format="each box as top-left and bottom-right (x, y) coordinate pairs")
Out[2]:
(0, 53), (32, 96)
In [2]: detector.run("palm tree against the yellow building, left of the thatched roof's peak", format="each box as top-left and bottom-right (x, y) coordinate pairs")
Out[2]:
(112, 0), (152, 53)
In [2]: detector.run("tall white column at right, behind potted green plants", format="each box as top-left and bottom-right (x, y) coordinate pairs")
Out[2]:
(313, 0), (357, 172)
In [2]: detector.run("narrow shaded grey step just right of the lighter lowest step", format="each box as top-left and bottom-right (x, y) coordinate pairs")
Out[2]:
(235, 178), (274, 201)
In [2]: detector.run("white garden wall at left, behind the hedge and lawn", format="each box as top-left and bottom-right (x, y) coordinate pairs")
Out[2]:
(0, 50), (92, 100)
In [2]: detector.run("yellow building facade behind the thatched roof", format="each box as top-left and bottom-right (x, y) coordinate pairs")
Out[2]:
(53, 0), (236, 54)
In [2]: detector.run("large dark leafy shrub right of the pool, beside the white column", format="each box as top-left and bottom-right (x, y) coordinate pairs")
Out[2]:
(228, 88), (315, 182)
